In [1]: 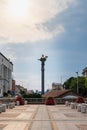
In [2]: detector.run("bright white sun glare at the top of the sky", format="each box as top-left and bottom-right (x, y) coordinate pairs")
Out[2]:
(9, 0), (29, 20)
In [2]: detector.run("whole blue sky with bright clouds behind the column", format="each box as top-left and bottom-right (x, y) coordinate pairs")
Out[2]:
(0, 0), (87, 90)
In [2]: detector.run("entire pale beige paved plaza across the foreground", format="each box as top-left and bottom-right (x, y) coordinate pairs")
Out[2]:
(0, 105), (87, 130)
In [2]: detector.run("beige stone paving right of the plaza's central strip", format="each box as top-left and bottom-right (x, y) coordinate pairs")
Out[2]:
(49, 105), (87, 130)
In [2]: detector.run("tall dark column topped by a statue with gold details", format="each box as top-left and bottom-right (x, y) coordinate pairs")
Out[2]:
(39, 54), (48, 94)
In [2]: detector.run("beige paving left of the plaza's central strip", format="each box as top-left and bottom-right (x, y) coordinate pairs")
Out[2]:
(0, 105), (38, 130)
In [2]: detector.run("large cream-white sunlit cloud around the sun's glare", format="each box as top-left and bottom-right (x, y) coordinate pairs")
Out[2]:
(0, 0), (74, 43)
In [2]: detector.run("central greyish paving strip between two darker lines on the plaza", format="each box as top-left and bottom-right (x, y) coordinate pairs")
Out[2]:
(29, 105), (53, 130)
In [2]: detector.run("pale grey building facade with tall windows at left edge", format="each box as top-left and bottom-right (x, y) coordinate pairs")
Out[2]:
(0, 53), (13, 97)
